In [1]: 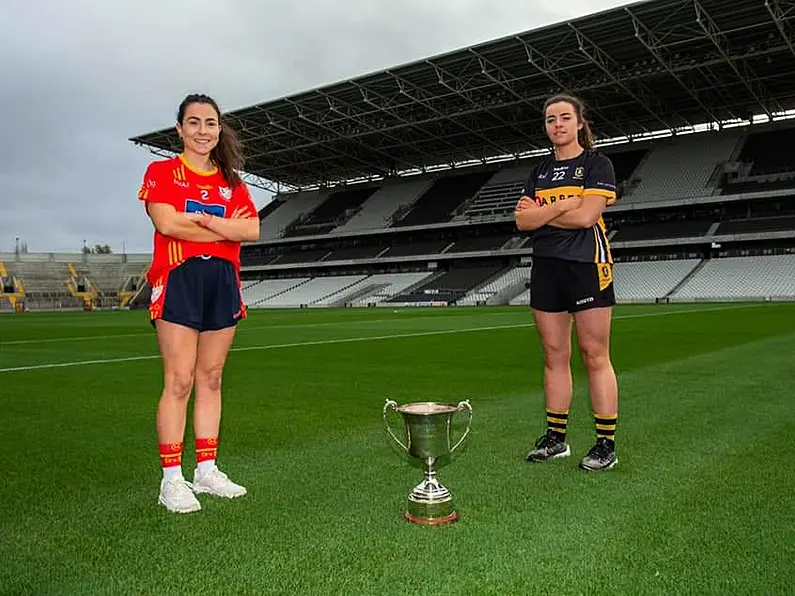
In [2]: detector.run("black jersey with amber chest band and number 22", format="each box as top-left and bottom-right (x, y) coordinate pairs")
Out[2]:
(522, 151), (616, 263)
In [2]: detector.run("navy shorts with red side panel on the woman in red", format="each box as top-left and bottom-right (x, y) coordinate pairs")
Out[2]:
(149, 257), (246, 331)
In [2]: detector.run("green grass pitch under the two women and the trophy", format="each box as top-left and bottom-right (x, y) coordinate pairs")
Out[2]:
(0, 303), (795, 595)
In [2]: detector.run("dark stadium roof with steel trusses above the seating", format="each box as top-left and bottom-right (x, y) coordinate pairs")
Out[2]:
(131, 0), (795, 188)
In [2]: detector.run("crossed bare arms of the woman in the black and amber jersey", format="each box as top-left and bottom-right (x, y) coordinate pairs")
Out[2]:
(514, 195), (607, 230)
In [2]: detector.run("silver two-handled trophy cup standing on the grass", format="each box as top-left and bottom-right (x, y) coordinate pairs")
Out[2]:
(383, 399), (472, 525)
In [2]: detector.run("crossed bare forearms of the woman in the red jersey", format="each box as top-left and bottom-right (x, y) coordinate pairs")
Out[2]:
(147, 203), (259, 242)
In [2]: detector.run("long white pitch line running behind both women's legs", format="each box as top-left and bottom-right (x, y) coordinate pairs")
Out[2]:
(0, 305), (761, 374)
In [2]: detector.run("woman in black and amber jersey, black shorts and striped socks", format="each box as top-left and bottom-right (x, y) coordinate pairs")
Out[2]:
(515, 95), (618, 470)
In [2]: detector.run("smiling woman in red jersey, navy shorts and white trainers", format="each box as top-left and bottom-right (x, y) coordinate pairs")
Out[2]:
(138, 95), (259, 513)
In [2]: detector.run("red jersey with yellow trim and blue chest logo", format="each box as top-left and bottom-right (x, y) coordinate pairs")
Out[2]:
(138, 155), (257, 284)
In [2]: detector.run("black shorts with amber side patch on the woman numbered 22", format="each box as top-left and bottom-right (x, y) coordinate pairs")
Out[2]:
(530, 257), (616, 313)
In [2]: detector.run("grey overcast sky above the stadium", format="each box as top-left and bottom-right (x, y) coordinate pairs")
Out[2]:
(0, 0), (636, 253)
